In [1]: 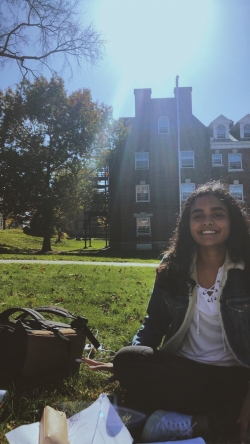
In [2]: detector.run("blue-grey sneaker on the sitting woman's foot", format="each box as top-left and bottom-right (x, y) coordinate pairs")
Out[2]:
(142, 410), (193, 442)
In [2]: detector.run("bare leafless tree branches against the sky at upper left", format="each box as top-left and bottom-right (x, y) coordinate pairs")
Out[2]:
(0, 0), (104, 76)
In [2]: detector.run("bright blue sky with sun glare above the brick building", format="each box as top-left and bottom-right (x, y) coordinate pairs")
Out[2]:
(0, 0), (250, 125)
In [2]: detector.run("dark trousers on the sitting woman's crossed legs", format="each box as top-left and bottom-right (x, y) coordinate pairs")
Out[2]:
(114, 346), (250, 434)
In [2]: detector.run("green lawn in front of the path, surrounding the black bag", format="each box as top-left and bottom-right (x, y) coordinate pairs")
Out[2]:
(0, 262), (155, 444)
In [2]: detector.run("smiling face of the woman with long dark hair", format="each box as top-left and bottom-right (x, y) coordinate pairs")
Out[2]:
(190, 194), (230, 248)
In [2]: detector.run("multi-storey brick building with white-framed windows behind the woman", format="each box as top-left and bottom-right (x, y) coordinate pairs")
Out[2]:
(110, 87), (250, 250)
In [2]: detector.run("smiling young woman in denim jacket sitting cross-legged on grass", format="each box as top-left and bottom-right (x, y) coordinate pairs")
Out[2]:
(86, 182), (250, 443)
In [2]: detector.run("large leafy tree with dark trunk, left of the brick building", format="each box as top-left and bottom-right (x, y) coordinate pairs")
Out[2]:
(0, 77), (111, 252)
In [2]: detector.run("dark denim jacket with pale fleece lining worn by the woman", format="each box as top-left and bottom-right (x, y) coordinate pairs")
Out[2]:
(133, 256), (250, 367)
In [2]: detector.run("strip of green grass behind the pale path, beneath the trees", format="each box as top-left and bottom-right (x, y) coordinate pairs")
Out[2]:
(0, 228), (160, 263)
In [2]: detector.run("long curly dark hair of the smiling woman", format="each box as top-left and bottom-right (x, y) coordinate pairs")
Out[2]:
(156, 181), (250, 294)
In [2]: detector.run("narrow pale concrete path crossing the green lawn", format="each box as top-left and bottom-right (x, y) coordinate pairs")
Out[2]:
(0, 259), (160, 268)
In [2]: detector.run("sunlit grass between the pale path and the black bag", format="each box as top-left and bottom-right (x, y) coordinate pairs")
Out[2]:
(0, 264), (155, 350)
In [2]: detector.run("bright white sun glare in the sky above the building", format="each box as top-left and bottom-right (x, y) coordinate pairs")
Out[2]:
(98, 0), (213, 115)
